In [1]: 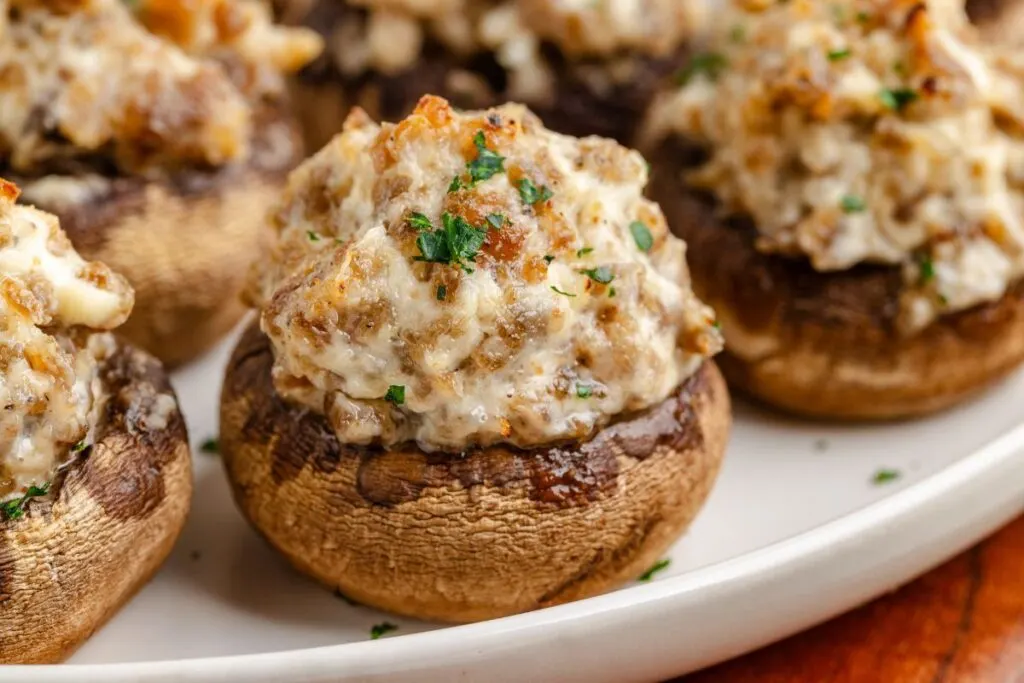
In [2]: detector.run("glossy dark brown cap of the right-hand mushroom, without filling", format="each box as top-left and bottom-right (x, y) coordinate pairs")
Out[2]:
(648, 140), (1024, 420)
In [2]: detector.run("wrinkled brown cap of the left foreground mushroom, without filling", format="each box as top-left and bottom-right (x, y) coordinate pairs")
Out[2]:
(0, 346), (191, 664)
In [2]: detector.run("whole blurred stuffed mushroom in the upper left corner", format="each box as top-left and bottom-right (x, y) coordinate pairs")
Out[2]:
(0, 0), (319, 364)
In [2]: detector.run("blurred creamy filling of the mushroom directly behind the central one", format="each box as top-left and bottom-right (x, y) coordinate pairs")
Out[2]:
(311, 0), (707, 101)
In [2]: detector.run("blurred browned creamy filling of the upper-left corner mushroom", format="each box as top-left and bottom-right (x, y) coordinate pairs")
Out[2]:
(0, 0), (316, 175)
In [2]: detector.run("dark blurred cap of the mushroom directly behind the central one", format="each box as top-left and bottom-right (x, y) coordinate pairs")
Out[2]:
(284, 0), (686, 151)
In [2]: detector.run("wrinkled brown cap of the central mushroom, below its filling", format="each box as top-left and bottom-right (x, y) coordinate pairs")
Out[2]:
(220, 326), (730, 622)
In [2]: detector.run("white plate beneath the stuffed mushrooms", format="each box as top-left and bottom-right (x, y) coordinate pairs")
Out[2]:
(8, 327), (1024, 683)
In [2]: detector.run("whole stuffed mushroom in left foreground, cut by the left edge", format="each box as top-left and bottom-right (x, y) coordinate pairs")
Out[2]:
(0, 180), (191, 664)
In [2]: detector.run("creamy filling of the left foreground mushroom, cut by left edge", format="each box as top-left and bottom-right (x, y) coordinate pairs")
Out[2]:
(0, 180), (134, 502)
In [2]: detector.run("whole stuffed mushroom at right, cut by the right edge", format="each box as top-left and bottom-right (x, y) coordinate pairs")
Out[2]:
(644, 0), (1024, 419)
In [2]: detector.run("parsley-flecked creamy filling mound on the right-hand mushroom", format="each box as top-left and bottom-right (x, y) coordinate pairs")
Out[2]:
(648, 0), (1024, 331)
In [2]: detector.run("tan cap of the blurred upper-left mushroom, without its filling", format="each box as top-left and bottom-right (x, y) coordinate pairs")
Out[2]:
(18, 111), (302, 366)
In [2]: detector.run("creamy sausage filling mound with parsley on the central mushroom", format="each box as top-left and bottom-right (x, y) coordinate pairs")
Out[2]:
(253, 97), (721, 451)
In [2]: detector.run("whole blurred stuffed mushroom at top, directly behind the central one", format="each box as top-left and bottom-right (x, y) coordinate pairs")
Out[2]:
(279, 0), (707, 148)
